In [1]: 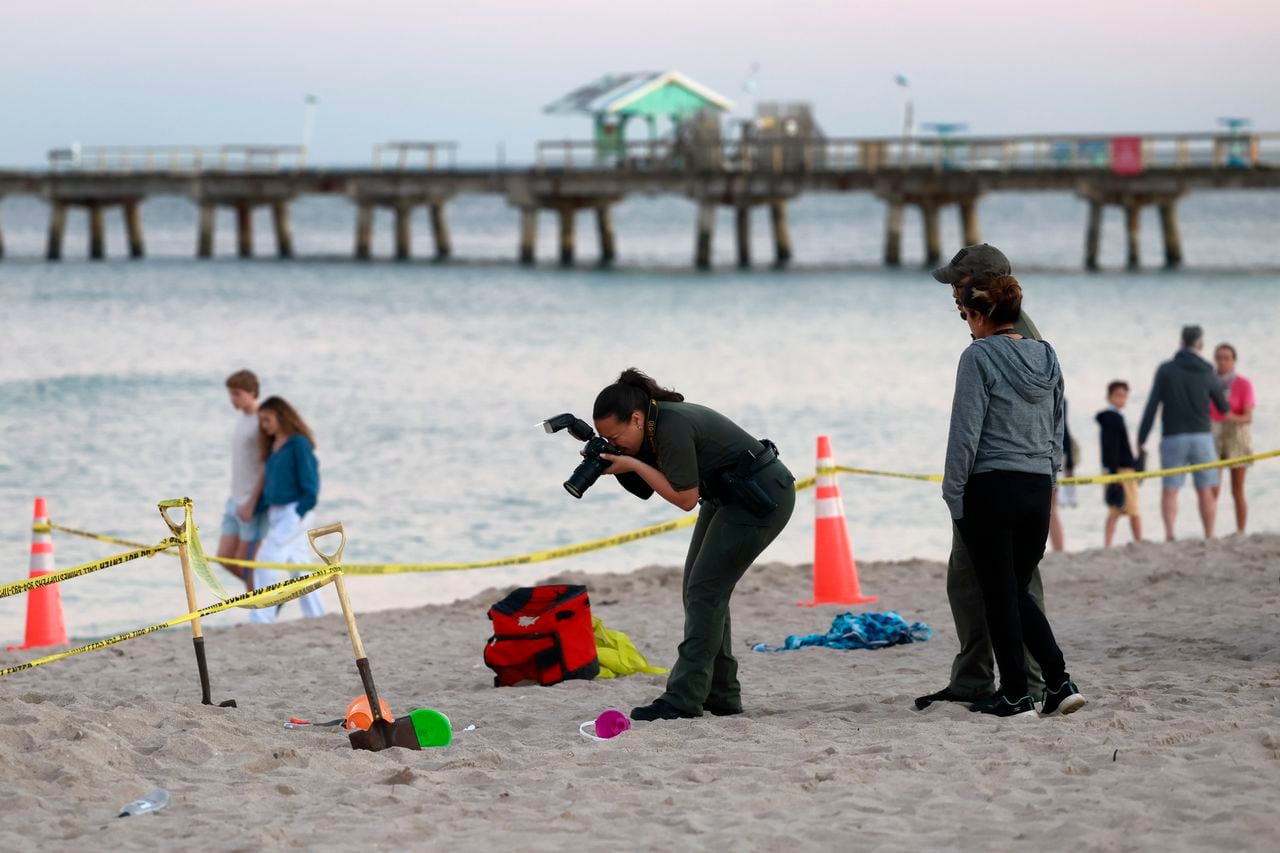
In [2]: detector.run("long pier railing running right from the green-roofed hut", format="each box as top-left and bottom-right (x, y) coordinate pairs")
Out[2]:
(535, 133), (1280, 173)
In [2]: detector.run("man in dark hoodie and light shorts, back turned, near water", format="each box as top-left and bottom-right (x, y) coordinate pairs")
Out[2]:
(1138, 325), (1230, 542)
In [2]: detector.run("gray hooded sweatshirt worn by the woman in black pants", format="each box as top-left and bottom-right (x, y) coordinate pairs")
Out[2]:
(942, 334), (1065, 519)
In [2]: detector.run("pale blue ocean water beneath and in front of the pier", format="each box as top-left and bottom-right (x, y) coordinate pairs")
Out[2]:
(0, 193), (1280, 640)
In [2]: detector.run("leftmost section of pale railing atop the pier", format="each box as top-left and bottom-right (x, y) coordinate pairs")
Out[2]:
(49, 145), (307, 173)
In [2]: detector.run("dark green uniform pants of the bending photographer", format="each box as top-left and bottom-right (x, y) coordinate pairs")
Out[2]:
(662, 462), (796, 713)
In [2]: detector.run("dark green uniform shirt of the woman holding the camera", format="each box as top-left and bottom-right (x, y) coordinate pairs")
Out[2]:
(646, 402), (763, 492)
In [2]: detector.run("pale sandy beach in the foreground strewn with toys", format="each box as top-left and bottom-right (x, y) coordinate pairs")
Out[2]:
(0, 535), (1280, 850)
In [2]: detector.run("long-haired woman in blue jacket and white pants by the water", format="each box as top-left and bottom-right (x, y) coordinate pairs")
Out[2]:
(250, 397), (324, 622)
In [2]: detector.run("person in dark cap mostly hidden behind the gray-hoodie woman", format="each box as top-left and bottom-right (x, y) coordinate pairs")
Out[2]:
(915, 243), (1044, 711)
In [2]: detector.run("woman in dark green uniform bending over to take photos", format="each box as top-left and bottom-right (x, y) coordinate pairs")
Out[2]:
(591, 368), (795, 720)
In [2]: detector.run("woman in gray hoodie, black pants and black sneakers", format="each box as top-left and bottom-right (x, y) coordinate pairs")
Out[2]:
(942, 275), (1084, 717)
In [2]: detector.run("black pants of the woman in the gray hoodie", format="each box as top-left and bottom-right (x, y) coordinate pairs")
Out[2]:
(956, 471), (1066, 699)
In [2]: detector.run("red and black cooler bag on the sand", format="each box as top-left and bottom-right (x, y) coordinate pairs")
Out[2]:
(484, 584), (600, 686)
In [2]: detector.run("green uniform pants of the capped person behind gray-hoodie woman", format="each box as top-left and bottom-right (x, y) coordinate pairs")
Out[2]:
(947, 523), (1044, 701)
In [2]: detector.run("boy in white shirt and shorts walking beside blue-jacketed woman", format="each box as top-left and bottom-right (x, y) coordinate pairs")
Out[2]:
(218, 370), (262, 589)
